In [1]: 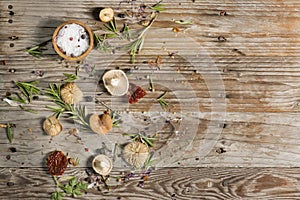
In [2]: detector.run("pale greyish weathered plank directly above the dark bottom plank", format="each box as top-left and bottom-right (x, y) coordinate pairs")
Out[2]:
(0, 109), (300, 168)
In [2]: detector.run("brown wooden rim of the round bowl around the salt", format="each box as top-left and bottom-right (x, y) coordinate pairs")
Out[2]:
(52, 20), (94, 61)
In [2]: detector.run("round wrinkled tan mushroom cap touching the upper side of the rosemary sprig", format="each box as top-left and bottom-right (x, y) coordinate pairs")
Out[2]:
(60, 82), (83, 104)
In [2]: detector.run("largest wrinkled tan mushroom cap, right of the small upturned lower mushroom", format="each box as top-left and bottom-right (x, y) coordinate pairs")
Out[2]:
(123, 141), (149, 168)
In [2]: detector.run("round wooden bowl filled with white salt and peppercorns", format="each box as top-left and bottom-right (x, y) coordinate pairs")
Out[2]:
(52, 20), (94, 60)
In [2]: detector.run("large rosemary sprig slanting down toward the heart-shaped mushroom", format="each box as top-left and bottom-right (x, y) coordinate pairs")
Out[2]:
(45, 84), (90, 128)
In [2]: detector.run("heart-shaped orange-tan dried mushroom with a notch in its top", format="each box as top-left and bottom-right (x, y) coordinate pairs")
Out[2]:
(90, 113), (113, 134)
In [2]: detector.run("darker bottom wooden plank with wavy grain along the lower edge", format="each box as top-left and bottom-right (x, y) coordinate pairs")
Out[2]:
(0, 168), (300, 200)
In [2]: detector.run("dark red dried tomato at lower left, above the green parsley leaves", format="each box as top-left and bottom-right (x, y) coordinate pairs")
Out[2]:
(47, 151), (68, 175)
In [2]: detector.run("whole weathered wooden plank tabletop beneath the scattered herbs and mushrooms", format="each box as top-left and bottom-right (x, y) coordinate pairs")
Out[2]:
(0, 0), (300, 200)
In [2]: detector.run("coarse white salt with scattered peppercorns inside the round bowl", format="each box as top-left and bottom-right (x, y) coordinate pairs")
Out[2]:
(56, 23), (90, 57)
